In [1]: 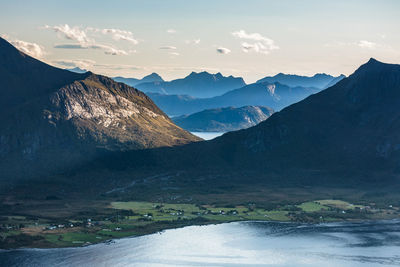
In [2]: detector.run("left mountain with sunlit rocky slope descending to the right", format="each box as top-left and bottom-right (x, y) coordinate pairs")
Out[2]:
(0, 38), (199, 180)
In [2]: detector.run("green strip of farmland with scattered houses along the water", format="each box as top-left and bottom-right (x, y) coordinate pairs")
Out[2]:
(0, 200), (400, 250)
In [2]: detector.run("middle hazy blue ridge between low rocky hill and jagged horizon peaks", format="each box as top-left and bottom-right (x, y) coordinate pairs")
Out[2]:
(147, 82), (321, 116)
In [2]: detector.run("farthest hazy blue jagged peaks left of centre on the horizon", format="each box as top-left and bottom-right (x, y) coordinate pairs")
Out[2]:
(136, 71), (246, 98)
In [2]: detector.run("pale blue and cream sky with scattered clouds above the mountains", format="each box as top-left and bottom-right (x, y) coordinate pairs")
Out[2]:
(0, 0), (400, 82)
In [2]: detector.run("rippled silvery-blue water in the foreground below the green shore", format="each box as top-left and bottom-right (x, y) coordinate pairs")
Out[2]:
(0, 220), (400, 267)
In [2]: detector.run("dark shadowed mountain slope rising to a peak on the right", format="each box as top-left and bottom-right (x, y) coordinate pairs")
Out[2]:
(62, 59), (400, 191)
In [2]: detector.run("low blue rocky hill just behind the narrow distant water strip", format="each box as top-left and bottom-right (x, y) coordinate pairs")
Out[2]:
(172, 106), (273, 132)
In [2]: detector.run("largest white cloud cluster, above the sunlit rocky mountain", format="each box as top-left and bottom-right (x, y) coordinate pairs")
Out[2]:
(44, 24), (130, 55)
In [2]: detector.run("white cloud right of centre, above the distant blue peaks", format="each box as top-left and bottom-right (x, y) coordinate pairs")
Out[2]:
(232, 30), (279, 54)
